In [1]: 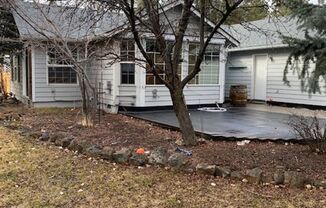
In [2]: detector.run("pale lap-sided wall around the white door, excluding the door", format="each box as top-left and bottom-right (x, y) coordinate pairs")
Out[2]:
(225, 49), (326, 106)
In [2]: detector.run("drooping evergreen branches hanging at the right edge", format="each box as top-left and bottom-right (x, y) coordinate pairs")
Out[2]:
(283, 0), (326, 94)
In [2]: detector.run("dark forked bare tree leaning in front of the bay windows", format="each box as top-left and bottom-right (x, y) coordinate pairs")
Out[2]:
(99, 0), (243, 146)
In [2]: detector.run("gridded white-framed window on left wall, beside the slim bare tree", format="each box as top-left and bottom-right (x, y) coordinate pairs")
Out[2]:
(47, 50), (77, 84)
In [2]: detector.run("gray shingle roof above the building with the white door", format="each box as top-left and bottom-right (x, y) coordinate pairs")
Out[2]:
(223, 16), (304, 50)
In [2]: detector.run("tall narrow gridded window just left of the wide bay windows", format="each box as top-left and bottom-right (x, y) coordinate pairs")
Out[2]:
(120, 40), (135, 84)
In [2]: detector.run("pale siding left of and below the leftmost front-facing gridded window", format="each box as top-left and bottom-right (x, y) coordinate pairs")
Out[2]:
(34, 48), (81, 102)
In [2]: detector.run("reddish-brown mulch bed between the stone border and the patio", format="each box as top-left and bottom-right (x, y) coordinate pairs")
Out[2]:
(0, 106), (326, 179)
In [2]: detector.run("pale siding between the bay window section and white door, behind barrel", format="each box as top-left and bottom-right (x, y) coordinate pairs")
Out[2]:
(225, 54), (252, 99)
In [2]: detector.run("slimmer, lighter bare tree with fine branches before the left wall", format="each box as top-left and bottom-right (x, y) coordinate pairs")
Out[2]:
(3, 0), (117, 126)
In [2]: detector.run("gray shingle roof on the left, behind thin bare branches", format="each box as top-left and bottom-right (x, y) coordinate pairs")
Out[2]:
(13, 1), (123, 41)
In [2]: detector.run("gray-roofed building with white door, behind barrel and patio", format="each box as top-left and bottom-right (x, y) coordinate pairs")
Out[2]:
(224, 17), (326, 106)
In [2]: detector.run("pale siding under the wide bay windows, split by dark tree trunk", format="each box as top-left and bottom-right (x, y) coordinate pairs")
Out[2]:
(145, 85), (220, 106)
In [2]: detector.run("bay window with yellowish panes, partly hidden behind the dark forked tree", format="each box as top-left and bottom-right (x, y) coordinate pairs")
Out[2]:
(146, 40), (181, 85)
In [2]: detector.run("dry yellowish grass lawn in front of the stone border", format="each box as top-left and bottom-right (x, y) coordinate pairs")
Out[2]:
(0, 127), (326, 208)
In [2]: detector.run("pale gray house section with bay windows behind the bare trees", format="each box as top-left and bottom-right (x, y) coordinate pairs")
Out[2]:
(7, 1), (238, 111)
